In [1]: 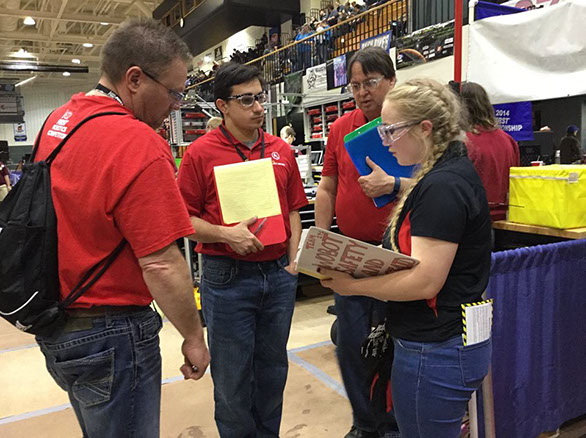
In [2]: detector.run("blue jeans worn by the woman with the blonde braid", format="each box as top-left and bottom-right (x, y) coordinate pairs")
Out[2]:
(391, 336), (492, 438)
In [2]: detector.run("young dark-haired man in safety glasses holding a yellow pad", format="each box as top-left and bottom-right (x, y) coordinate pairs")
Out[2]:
(179, 63), (307, 438)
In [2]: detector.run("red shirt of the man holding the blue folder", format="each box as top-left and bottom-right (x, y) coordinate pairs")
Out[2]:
(322, 109), (395, 242)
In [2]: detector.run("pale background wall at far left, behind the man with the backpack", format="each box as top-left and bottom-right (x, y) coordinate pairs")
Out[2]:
(0, 81), (93, 155)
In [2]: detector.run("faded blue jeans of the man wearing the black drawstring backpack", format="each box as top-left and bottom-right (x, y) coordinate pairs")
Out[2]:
(37, 307), (162, 438)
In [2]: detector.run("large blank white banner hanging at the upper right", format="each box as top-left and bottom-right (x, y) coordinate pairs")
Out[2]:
(468, 0), (586, 104)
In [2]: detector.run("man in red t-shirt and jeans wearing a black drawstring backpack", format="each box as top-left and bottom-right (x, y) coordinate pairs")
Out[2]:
(35, 20), (210, 438)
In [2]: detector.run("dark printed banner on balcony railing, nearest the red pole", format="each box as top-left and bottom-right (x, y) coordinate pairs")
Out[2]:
(396, 20), (454, 70)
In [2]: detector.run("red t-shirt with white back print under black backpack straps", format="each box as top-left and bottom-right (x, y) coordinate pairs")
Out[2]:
(36, 93), (193, 307)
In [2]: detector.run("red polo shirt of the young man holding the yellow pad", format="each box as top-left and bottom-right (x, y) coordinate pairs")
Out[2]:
(178, 123), (307, 261)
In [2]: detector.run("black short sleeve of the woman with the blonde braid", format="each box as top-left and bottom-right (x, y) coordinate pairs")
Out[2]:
(410, 174), (473, 243)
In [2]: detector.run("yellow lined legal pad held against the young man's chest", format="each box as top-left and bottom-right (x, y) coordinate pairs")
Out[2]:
(214, 158), (281, 224)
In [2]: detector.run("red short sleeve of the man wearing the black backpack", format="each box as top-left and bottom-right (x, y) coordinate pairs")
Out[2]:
(114, 157), (194, 258)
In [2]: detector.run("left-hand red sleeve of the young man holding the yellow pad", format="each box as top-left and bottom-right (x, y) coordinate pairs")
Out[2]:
(177, 150), (206, 217)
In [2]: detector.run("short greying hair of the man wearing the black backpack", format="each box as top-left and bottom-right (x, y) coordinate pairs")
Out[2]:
(101, 19), (192, 82)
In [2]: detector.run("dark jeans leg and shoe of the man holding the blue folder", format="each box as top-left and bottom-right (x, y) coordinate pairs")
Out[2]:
(334, 294), (397, 433)
